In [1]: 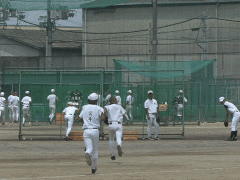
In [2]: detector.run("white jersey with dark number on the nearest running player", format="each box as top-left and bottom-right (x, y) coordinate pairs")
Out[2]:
(79, 104), (104, 129)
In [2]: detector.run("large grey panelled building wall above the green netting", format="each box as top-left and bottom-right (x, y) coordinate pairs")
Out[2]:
(83, 3), (240, 78)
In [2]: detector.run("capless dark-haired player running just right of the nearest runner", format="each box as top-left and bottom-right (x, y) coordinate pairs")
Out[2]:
(104, 97), (126, 160)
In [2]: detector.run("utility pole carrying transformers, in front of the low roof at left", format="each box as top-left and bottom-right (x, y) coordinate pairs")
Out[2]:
(46, 0), (52, 68)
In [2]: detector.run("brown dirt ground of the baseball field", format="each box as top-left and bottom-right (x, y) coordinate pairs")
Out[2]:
(0, 123), (240, 180)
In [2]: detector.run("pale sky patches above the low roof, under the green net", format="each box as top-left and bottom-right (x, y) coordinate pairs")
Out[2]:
(6, 9), (82, 27)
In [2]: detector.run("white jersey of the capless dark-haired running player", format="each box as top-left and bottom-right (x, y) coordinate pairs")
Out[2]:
(105, 104), (126, 122)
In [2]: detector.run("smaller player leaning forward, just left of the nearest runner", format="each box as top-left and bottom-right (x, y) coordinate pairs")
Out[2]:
(62, 102), (79, 141)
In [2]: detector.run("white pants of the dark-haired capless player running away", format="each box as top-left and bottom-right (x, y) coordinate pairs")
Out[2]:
(108, 122), (123, 156)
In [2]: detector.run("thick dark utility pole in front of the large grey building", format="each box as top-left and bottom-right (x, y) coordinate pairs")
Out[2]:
(152, 0), (158, 60)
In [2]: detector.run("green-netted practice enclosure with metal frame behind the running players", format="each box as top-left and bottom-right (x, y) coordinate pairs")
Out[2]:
(0, 60), (216, 140)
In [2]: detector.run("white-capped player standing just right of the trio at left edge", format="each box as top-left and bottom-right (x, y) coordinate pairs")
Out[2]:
(21, 91), (32, 126)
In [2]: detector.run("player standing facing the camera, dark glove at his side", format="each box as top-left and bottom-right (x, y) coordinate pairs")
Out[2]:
(144, 90), (159, 140)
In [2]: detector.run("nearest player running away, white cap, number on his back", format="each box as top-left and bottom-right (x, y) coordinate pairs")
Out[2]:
(79, 93), (103, 174)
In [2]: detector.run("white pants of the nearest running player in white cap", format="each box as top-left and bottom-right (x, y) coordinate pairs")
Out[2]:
(83, 129), (99, 158)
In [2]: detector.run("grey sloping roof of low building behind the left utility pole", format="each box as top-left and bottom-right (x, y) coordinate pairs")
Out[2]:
(0, 29), (82, 49)
